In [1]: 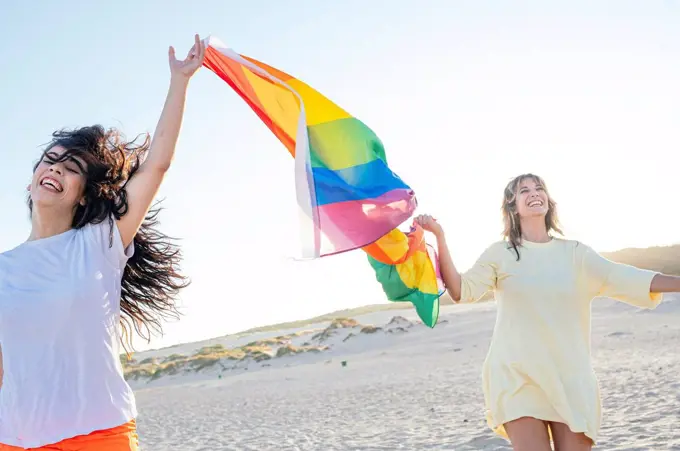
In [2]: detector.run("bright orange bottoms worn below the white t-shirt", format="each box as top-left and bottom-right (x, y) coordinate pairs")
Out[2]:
(0, 420), (139, 451)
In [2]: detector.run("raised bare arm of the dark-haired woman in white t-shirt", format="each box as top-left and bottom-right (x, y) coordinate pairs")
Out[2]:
(118, 35), (205, 247)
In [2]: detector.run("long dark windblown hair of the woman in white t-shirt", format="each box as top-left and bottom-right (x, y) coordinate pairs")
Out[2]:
(28, 125), (189, 349)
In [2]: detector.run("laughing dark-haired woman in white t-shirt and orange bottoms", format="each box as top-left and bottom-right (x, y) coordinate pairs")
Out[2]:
(0, 35), (205, 451)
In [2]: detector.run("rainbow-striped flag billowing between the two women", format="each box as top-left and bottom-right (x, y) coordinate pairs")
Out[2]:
(204, 37), (444, 327)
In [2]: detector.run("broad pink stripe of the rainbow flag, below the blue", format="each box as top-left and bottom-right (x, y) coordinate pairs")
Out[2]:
(318, 189), (416, 255)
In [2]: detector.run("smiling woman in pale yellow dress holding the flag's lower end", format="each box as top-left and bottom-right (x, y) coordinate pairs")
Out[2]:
(416, 174), (680, 451)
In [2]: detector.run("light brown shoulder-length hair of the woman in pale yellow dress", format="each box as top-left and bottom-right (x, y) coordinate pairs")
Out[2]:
(501, 174), (564, 260)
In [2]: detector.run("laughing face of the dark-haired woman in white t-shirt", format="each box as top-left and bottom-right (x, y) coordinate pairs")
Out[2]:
(30, 146), (87, 212)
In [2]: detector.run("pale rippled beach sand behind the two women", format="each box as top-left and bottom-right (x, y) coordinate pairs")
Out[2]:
(131, 296), (680, 451)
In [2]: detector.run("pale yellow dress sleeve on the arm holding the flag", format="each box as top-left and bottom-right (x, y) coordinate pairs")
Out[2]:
(460, 243), (502, 303)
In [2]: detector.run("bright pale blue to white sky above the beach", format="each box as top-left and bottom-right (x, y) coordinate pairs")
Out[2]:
(0, 0), (680, 349)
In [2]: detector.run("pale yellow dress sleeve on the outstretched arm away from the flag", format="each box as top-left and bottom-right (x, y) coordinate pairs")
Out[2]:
(580, 244), (663, 309)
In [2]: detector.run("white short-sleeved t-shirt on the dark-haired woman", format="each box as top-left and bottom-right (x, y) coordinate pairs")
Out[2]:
(0, 219), (137, 448)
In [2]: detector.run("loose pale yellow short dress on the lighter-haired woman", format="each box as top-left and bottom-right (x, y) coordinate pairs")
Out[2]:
(461, 238), (662, 442)
